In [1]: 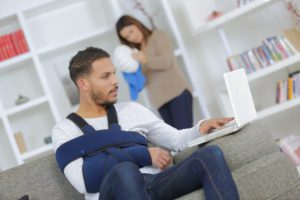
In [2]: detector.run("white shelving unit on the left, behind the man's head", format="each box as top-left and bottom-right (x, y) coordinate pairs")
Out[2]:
(0, 0), (122, 170)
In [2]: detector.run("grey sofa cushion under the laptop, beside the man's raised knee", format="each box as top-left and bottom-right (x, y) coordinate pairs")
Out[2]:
(174, 122), (279, 170)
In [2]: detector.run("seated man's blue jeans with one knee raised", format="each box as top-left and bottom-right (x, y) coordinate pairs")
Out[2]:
(99, 146), (239, 200)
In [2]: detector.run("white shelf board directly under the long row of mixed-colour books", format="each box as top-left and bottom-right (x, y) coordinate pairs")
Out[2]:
(247, 53), (300, 82)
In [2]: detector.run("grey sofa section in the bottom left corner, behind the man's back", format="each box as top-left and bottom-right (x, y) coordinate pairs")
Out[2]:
(0, 154), (84, 200)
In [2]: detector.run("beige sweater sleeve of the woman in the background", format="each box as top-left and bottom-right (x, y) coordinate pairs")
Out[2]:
(145, 31), (174, 70)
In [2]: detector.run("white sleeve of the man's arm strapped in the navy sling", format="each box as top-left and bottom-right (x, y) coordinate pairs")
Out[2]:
(52, 121), (86, 193)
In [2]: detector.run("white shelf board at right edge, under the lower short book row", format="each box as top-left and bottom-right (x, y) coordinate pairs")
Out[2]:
(258, 98), (300, 119)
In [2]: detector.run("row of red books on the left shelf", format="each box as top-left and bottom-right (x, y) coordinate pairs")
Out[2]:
(0, 29), (29, 62)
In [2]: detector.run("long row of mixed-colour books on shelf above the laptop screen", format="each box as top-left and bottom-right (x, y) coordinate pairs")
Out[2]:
(227, 36), (297, 74)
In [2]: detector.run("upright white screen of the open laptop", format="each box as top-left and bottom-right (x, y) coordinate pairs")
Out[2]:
(223, 69), (257, 126)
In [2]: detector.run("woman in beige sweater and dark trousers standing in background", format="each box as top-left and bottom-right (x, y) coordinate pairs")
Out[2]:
(116, 15), (193, 129)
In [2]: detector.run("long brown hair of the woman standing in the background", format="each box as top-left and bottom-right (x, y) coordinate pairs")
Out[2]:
(116, 15), (152, 50)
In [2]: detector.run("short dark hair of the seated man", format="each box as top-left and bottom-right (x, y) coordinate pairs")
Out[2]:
(69, 47), (110, 86)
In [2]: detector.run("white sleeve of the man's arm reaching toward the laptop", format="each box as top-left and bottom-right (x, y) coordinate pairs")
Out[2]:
(126, 103), (202, 152)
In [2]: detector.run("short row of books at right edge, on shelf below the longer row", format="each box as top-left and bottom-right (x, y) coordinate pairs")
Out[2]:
(276, 72), (300, 103)
